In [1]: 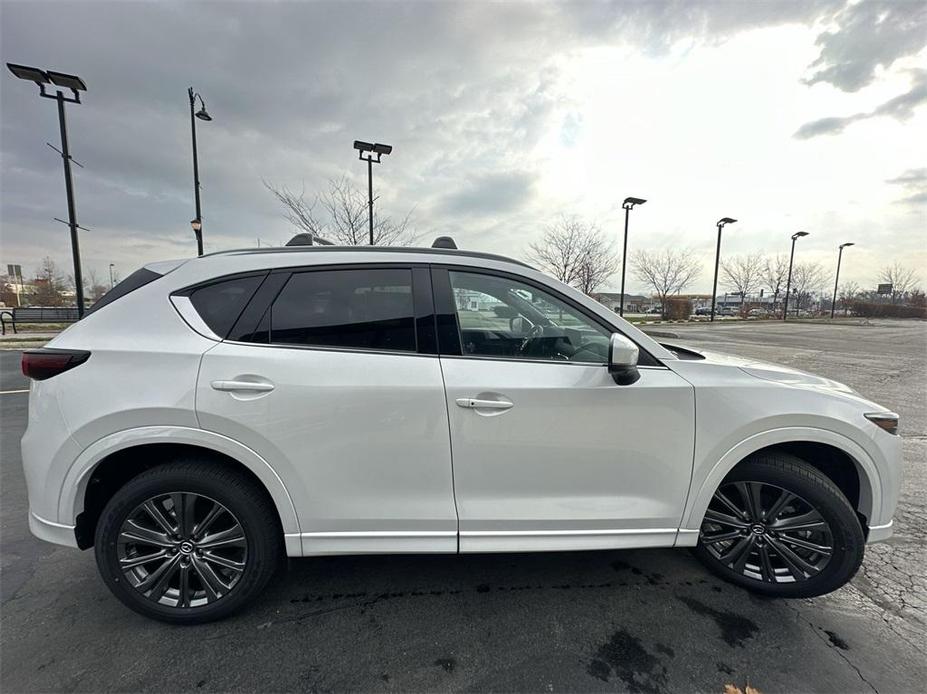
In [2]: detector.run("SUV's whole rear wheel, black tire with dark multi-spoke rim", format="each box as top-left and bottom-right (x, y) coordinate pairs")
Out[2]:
(94, 459), (282, 624)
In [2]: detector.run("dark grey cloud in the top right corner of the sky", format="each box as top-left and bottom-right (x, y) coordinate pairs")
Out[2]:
(806, 0), (927, 92)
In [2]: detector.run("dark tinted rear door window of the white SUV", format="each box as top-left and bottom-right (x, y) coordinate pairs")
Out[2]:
(270, 269), (415, 352)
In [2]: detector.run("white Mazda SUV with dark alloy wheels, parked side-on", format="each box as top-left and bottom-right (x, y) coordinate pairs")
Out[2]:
(22, 246), (901, 623)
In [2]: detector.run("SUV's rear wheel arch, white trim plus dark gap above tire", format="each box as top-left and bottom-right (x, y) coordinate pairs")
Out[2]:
(59, 436), (301, 556)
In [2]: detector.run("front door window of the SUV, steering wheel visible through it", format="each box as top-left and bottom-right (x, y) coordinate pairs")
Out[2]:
(448, 272), (609, 364)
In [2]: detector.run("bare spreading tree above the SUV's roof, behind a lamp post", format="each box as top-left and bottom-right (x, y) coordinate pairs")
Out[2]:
(264, 178), (415, 246)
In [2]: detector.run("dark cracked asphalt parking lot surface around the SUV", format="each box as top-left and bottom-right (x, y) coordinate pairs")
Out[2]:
(0, 321), (927, 694)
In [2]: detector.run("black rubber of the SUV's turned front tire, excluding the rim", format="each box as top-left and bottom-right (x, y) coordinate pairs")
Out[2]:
(694, 455), (865, 598)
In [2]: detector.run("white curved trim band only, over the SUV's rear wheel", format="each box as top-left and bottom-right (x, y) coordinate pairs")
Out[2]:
(58, 426), (302, 556)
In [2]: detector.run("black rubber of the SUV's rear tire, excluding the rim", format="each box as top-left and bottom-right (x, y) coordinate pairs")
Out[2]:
(94, 465), (280, 624)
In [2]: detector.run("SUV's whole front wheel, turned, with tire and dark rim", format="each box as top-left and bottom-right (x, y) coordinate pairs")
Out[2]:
(694, 453), (865, 598)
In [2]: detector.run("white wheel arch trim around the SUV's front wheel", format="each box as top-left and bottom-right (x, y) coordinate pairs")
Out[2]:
(676, 427), (882, 546)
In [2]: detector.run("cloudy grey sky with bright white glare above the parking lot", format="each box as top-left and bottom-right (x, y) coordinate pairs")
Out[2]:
(0, 0), (927, 291)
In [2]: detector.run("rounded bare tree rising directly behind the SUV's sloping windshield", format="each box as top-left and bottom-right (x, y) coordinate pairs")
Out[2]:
(530, 216), (618, 294)
